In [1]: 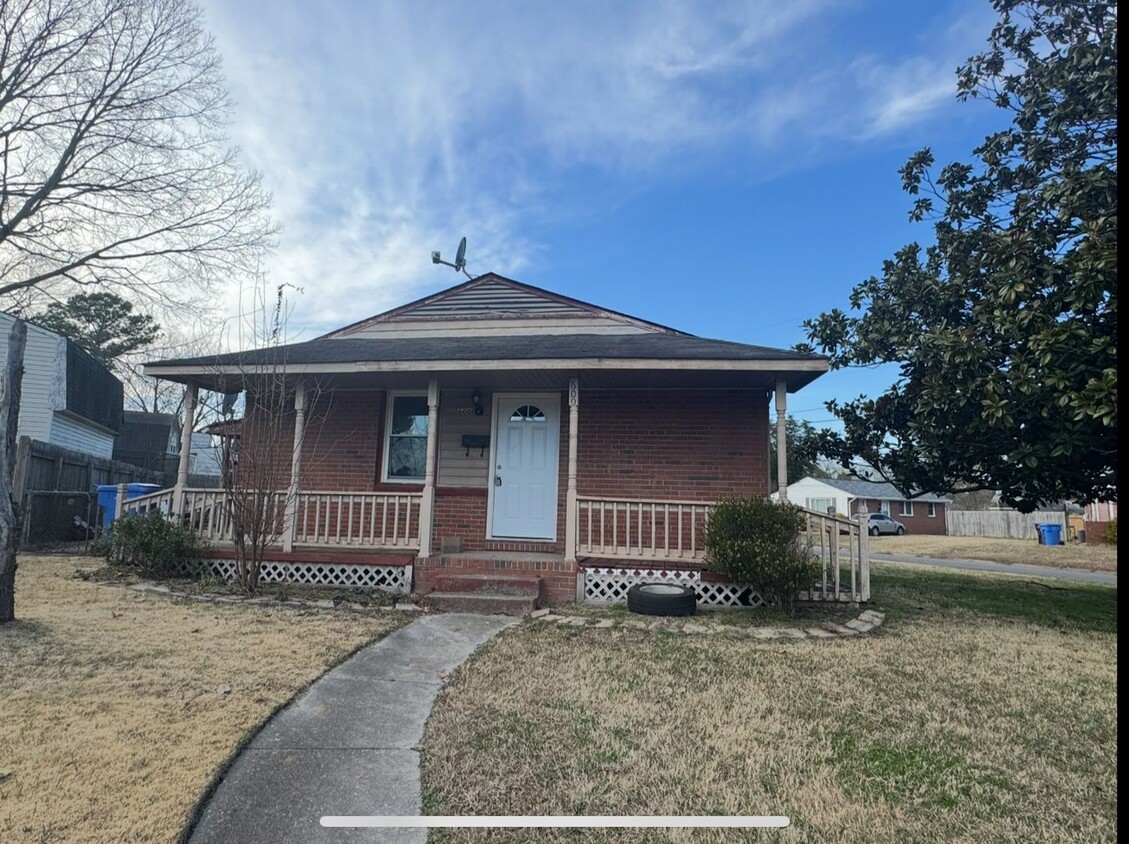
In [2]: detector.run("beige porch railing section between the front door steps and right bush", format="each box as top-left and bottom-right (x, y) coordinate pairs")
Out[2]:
(575, 495), (712, 562)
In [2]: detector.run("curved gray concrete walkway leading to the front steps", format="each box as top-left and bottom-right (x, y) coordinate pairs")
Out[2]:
(190, 613), (518, 844)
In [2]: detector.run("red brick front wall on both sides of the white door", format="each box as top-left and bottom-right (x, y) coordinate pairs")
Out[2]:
(240, 388), (776, 553)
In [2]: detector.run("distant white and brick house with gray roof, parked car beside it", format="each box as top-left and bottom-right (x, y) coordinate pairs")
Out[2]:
(788, 477), (952, 534)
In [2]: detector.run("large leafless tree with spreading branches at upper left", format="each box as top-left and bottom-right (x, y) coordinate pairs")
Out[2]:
(0, 0), (275, 618)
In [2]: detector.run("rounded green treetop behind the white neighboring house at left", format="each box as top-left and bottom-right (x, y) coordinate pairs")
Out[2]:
(33, 292), (160, 368)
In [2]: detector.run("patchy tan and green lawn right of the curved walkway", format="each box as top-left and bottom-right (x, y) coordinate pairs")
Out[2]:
(423, 563), (1117, 842)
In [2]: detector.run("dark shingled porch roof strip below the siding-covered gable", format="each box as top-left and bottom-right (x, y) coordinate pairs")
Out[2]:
(149, 334), (824, 367)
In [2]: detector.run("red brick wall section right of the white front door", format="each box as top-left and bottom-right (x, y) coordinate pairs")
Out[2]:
(577, 389), (769, 501)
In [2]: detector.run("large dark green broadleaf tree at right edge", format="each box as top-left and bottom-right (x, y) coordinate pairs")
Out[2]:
(805, 0), (1118, 511)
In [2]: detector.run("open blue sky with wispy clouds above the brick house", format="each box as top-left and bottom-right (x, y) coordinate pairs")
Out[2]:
(196, 0), (1006, 423)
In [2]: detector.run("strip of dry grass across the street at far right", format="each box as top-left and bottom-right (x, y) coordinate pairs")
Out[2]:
(870, 534), (1118, 571)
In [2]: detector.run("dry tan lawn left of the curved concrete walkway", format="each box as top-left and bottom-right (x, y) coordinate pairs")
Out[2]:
(0, 556), (401, 842)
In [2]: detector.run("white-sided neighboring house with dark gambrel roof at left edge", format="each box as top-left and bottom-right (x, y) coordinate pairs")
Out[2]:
(0, 311), (122, 458)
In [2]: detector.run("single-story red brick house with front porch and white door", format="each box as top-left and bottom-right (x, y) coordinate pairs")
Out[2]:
(146, 273), (835, 599)
